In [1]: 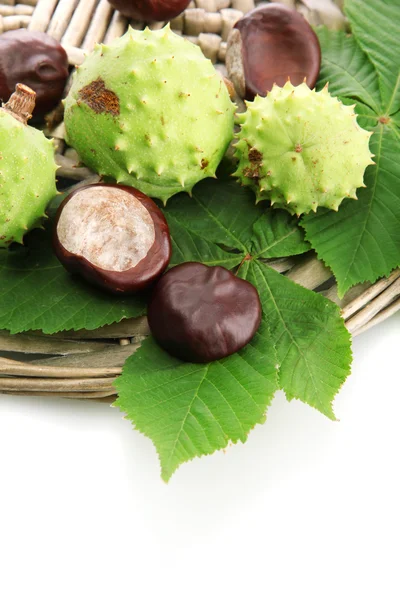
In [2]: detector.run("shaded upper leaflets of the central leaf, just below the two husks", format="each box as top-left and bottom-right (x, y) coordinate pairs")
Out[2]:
(164, 179), (310, 268)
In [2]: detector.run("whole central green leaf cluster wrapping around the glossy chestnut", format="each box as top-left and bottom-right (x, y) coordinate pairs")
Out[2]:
(116, 180), (351, 480)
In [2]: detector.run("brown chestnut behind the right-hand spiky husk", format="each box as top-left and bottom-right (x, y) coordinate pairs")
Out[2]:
(226, 3), (321, 100)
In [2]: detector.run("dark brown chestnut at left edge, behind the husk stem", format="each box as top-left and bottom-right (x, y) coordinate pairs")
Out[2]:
(0, 29), (69, 118)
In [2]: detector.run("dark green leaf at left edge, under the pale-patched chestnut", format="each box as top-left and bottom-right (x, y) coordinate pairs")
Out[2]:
(0, 230), (146, 333)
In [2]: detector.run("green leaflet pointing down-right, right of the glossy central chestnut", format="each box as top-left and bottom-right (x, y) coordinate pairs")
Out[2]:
(247, 261), (351, 419)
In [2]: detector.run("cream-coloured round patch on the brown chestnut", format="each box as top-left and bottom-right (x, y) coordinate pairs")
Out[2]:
(57, 186), (155, 271)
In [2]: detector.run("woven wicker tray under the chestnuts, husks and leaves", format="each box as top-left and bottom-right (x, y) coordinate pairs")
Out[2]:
(0, 0), (400, 402)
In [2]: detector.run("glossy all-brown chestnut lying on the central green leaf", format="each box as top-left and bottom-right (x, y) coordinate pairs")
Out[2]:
(147, 262), (261, 363)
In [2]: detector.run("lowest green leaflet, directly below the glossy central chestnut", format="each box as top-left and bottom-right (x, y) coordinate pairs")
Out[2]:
(115, 324), (277, 481)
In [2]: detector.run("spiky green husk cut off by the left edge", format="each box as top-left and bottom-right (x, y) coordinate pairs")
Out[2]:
(0, 109), (57, 248)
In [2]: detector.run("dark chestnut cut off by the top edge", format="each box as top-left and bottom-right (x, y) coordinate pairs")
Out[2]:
(109, 0), (190, 21)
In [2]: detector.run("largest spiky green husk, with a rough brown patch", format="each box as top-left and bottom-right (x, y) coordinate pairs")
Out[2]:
(65, 26), (234, 202)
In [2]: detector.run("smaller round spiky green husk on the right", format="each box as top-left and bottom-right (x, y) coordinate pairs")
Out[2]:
(235, 82), (373, 215)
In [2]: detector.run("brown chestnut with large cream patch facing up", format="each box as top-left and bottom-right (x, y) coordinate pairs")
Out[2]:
(53, 183), (171, 294)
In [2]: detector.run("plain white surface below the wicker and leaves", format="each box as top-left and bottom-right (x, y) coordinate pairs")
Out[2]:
(0, 314), (400, 600)
